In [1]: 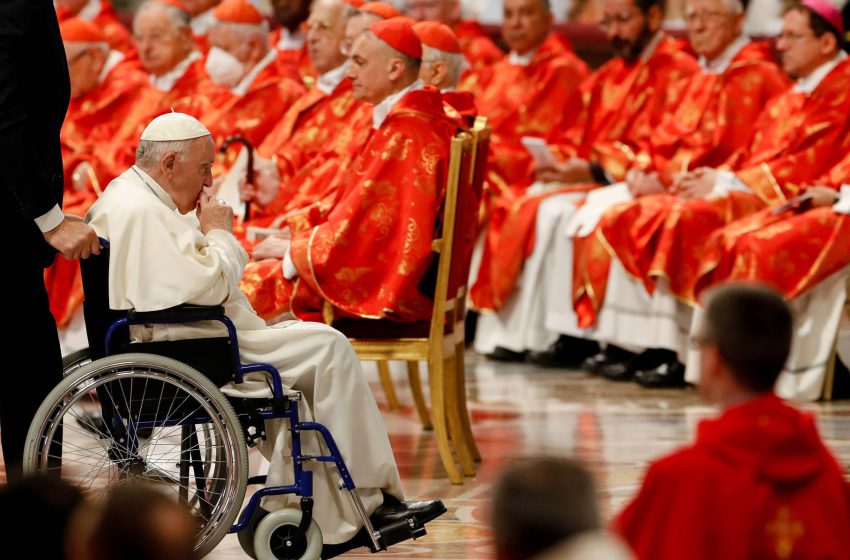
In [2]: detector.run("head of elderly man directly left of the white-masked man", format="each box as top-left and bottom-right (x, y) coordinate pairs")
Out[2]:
(133, 0), (194, 76)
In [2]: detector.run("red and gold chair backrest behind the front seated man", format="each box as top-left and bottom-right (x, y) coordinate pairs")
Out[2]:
(430, 117), (490, 341)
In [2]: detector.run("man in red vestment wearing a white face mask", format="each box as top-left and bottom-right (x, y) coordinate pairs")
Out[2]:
(200, 0), (304, 145)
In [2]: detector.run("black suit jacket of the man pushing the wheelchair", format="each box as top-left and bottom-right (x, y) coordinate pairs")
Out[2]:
(0, 0), (71, 266)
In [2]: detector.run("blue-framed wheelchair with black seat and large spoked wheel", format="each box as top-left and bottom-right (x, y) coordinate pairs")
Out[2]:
(24, 240), (426, 560)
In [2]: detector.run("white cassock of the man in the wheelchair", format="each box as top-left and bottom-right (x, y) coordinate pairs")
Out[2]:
(86, 166), (402, 544)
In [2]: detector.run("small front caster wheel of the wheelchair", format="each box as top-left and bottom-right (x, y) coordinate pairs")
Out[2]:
(254, 508), (322, 560)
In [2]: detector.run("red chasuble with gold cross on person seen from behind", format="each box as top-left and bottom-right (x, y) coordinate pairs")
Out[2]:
(614, 394), (850, 560)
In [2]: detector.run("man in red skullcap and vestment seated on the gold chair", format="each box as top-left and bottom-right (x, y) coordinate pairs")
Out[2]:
(242, 18), (458, 321)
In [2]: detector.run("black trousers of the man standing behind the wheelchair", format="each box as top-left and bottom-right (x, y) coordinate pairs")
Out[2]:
(0, 241), (62, 480)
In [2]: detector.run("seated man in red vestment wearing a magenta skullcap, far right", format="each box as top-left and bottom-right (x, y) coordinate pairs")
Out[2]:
(598, 0), (850, 386)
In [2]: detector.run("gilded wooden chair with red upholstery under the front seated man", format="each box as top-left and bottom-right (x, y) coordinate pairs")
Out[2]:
(324, 117), (490, 484)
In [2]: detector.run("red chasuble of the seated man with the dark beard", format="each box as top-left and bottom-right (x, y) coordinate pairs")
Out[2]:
(471, 36), (698, 309)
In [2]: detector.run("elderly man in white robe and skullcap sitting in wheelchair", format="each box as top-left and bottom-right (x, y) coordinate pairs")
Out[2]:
(87, 113), (445, 548)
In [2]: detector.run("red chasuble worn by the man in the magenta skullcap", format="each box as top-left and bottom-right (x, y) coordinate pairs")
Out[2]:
(599, 60), (850, 302)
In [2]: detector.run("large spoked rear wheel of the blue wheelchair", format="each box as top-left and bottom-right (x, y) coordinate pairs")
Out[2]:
(24, 354), (248, 557)
